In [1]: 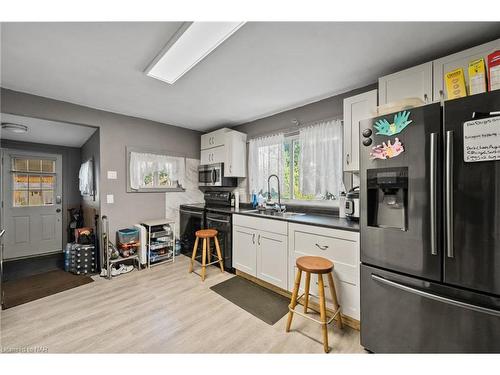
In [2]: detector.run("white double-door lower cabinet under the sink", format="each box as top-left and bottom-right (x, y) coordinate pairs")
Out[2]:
(233, 215), (288, 289)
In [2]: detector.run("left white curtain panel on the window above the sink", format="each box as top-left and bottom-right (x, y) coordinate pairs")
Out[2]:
(248, 133), (285, 198)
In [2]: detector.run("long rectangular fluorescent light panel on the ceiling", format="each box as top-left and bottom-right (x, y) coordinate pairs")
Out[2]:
(146, 22), (245, 84)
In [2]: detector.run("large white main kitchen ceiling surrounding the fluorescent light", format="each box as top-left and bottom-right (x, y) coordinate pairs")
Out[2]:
(1, 22), (500, 130)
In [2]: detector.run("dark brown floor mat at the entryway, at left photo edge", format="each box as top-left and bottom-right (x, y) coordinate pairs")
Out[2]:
(2, 270), (94, 309)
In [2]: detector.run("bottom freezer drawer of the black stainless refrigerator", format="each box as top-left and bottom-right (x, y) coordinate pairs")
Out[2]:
(361, 265), (500, 353)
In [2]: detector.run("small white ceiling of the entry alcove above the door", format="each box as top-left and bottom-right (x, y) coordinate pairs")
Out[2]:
(0, 113), (96, 147)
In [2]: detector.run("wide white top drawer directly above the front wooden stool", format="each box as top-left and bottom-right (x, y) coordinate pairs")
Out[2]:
(293, 230), (359, 266)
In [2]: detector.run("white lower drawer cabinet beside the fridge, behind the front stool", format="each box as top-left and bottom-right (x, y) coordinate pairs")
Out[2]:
(288, 223), (360, 320)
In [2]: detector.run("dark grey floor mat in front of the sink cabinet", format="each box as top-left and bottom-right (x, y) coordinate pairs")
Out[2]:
(210, 276), (290, 325)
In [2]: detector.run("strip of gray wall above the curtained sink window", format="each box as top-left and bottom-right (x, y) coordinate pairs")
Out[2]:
(233, 83), (378, 138)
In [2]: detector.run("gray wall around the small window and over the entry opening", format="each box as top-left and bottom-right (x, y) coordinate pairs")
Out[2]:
(1, 88), (201, 236)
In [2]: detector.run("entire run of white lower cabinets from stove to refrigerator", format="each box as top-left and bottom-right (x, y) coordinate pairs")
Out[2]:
(233, 214), (360, 320)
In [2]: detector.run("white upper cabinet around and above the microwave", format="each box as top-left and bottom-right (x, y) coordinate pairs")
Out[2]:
(200, 128), (247, 177)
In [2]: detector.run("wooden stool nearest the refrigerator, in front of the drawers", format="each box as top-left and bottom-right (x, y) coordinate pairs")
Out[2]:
(286, 256), (342, 353)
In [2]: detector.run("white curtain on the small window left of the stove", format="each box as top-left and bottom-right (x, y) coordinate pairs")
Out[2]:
(129, 152), (185, 190)
